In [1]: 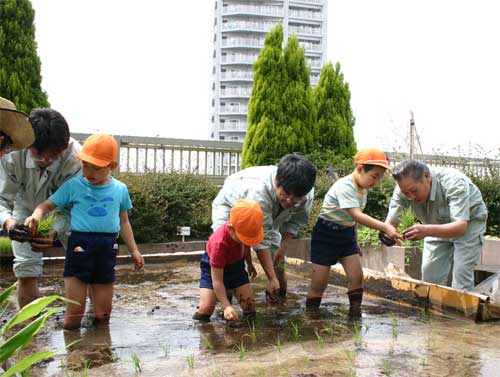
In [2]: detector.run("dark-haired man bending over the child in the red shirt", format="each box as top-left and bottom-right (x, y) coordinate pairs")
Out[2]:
(212, 154), (316, 303)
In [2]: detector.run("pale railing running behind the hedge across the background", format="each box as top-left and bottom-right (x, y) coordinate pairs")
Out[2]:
(71, 134), (500, 183)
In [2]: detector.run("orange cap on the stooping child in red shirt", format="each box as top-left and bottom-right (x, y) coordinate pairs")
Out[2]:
(229, 199), (264, 246)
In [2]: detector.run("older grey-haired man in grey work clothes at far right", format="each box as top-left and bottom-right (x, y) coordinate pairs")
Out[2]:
(386, 160), (488, 290)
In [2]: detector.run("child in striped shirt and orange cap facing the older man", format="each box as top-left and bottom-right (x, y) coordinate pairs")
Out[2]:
(306, 148), (402, 317)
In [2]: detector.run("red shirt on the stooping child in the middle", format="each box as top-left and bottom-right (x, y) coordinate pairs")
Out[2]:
(207, 223), (250, 268)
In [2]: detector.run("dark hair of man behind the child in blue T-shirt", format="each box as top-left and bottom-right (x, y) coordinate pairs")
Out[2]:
(29, 109), (70, 152)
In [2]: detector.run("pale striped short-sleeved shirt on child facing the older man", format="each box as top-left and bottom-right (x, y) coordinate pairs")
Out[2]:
(319, 174), (368, 226)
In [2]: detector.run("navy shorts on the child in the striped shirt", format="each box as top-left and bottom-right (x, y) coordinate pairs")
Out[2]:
(311, 218), (359, 266)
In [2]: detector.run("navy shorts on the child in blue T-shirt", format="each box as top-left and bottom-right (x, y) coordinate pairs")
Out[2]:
(64, 231), (118, 284)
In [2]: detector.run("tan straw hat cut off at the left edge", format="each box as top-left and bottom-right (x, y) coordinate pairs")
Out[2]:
(0, 97), (35, 149)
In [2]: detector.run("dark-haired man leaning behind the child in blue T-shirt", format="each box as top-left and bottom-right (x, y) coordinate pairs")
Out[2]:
(0, 109), (81, 307)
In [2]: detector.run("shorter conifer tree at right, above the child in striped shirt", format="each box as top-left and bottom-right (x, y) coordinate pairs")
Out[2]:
(314, 63), (356, 157)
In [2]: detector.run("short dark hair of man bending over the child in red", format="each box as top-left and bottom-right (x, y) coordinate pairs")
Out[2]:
(276, 154), (316, 196)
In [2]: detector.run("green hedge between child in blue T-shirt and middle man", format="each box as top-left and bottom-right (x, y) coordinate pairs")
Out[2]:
(117, 173), (218, 243)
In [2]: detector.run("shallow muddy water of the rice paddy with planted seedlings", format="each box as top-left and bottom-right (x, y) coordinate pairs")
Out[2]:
(0, 262), (500, 377)
